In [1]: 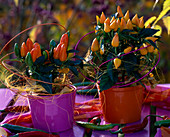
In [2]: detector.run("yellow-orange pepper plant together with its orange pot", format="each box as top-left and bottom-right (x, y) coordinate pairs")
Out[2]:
(85, 6), (160, 124)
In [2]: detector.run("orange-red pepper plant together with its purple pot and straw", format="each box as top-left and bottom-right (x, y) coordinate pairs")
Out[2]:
(6, 29), (83, 132)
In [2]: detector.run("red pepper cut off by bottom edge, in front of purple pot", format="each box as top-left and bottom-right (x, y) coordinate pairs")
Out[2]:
(15, 131), (60, 137)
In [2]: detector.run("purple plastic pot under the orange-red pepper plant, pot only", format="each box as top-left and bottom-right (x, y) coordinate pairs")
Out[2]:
(28, 86), (76, 132)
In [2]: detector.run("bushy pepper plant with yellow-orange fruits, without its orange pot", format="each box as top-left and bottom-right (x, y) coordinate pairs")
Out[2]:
(86, 6), (160, 91)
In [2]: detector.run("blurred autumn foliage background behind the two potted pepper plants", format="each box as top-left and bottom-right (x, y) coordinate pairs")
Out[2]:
(0, 0), (170, 83)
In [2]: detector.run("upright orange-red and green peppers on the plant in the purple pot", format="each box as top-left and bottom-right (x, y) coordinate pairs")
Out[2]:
(14, 33), (68, 66)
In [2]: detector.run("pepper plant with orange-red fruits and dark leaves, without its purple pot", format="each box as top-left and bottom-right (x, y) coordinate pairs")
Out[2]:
(14, 32), (83, 94)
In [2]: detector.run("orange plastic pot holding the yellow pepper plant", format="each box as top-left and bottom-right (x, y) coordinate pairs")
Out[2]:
(97, 85), (144, 124)
